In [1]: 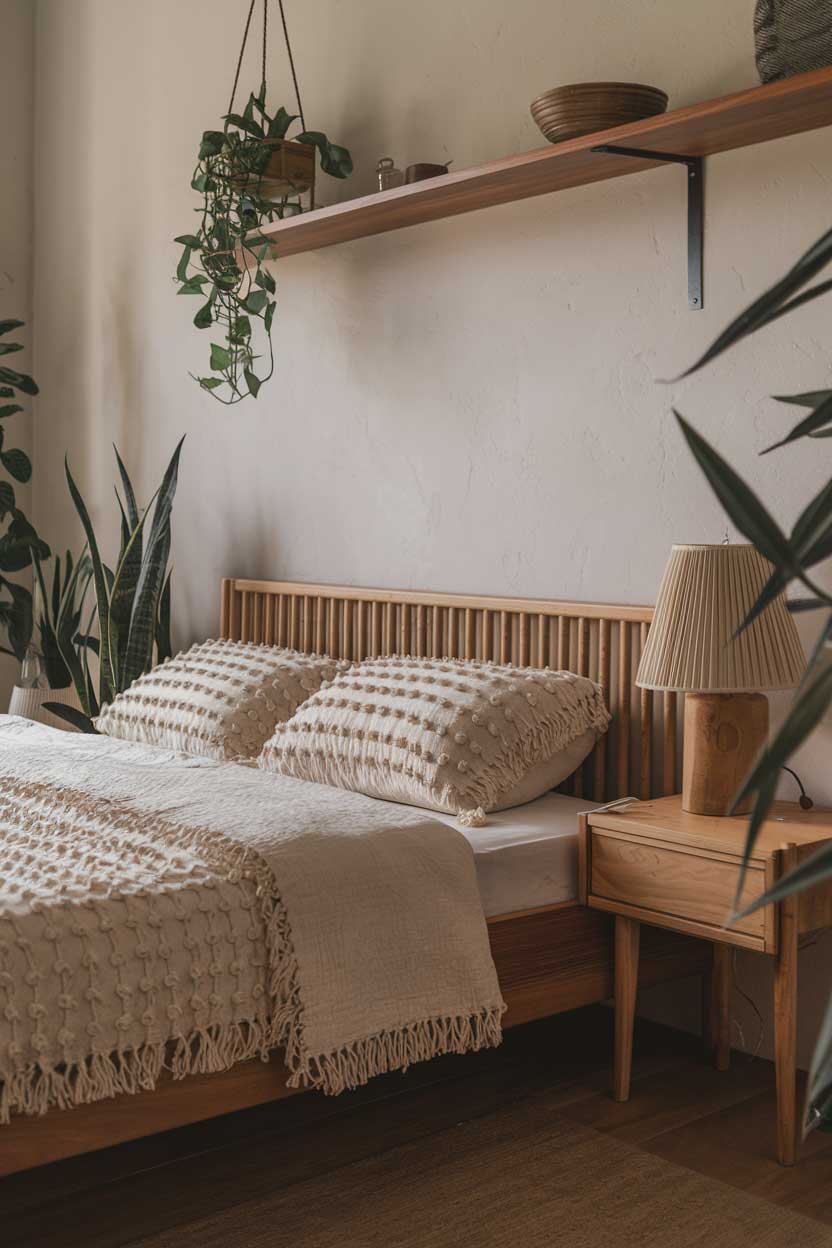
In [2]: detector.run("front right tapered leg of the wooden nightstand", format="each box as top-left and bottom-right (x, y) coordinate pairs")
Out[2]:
(775, 846), (797, 1166)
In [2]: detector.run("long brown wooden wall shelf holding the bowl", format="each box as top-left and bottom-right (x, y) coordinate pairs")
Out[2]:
(262, 67), (832, 258)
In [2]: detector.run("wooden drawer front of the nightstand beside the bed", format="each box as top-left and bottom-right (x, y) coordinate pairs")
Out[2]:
(589, 829), (770, 946)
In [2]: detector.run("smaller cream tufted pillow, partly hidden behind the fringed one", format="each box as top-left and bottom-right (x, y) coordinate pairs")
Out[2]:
(95, 641), (348, 761)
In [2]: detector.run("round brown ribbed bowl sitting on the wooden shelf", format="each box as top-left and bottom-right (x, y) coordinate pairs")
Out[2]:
(531, 82), (667, 144)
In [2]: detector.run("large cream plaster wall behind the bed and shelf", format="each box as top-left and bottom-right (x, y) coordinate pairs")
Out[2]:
(27, 0), (832, 1063)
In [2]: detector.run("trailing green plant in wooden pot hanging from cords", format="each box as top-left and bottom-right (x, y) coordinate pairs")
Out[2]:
(176, 82), (353, 404)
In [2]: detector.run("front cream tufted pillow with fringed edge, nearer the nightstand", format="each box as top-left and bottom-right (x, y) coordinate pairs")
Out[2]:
(259, 658), (610, 820)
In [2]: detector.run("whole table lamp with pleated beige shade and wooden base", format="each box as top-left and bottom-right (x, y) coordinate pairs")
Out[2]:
(636, 543), (806, 815)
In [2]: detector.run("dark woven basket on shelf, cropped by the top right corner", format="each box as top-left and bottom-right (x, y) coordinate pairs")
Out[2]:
(753, 0), (832, 82)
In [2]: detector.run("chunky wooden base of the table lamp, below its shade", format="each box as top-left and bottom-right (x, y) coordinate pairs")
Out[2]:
(682, 694), (768, 815)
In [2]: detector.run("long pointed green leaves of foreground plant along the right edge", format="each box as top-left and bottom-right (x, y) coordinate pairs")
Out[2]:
(675, 222), (832, 1129)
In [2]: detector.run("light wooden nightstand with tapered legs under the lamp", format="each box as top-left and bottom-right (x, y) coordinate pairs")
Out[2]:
(580, 796), (832, 1166)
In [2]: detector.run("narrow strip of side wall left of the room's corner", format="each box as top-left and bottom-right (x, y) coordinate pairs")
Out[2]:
(0, 0), (35, 711)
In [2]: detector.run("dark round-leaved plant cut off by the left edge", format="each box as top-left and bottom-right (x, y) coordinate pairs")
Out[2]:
(0, 321), (50, 661)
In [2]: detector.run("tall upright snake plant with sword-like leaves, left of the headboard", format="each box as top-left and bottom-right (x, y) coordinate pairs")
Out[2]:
(46, 438), (185, 733)
